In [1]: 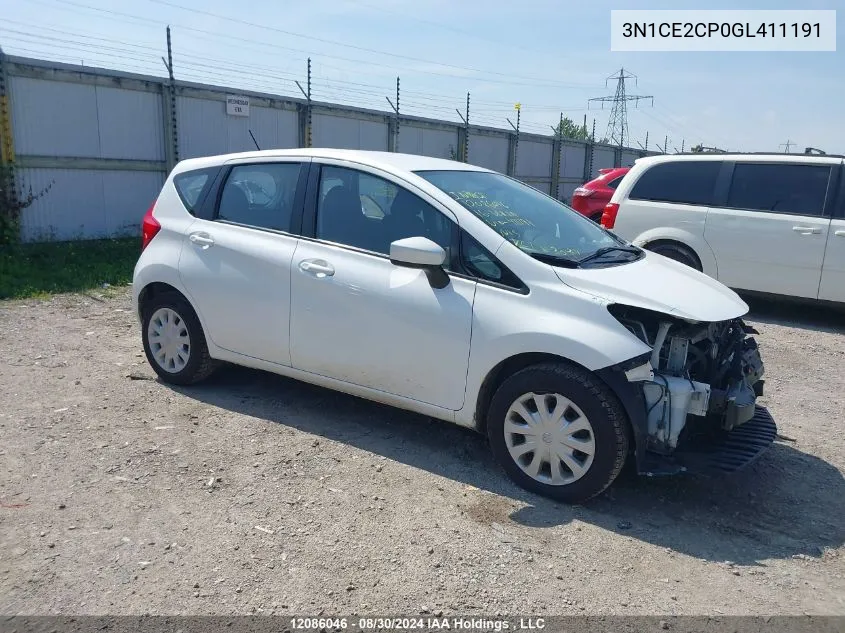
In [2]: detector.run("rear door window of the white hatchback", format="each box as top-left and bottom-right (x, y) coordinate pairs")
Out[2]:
(217, 163), (300, 231)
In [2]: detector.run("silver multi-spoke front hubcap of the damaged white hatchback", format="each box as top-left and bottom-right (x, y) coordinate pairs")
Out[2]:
(505, 393), (596, 486)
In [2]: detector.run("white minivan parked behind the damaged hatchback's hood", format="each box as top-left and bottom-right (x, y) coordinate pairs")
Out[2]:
(602, 154), (845, 302)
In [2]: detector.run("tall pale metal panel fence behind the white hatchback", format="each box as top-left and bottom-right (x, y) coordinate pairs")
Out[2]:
(0, 57), (645, 241)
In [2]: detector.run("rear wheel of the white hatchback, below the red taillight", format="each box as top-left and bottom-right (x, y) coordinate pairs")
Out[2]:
(141, 292), (217, 385)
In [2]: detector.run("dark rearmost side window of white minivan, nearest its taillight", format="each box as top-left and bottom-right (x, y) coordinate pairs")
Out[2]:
(628, 160), (722, 205)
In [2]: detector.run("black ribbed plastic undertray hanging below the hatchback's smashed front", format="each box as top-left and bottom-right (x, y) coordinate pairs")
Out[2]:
(639, 406), (778, 476)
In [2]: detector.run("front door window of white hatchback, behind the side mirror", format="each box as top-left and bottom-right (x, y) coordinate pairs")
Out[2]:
(316, 166), (453, 256)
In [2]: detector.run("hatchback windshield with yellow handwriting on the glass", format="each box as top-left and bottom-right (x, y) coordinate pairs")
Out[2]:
(416, 171), (640, 265)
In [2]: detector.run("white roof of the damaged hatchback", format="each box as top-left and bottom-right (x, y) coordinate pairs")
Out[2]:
(174, 148), (490, 172)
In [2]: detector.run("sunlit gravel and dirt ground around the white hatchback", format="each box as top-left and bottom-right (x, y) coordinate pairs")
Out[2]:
(0, 289), (845, 616)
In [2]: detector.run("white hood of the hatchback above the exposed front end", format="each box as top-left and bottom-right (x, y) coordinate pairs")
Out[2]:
(555, 251), (748, 322)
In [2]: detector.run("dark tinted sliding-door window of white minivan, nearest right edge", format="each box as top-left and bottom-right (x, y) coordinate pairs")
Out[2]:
(727, 163), (830, 216)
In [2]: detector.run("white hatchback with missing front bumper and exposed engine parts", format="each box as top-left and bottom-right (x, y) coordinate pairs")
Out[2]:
(133, 149), (776, 502)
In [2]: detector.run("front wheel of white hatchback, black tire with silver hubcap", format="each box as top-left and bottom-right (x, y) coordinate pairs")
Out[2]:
(487, 363), (630, 503)
